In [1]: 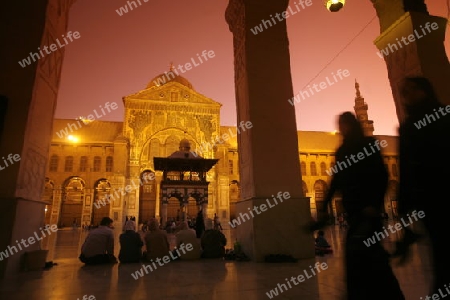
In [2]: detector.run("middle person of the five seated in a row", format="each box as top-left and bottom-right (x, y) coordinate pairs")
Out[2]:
(144, 219), (170, 261)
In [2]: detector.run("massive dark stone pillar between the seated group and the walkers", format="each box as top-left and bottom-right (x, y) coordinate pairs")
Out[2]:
(226, 0), (314, 262)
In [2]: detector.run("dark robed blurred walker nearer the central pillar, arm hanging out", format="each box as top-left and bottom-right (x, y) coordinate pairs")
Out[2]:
(315, 112), (405, 300)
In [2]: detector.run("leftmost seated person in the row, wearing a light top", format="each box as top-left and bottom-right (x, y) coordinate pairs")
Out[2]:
(79, 217), (117, 265)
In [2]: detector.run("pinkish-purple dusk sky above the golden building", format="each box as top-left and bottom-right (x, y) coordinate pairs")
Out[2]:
(55, 0), (450, 135)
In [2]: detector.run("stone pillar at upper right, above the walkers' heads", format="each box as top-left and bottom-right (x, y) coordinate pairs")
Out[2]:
(372, 0), (450, 122)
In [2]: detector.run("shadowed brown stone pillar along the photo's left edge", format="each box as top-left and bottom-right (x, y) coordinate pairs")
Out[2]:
(0, 0), (76, 278)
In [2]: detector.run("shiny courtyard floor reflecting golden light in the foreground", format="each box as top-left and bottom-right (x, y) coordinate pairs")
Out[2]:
(0, 221), (431, 300)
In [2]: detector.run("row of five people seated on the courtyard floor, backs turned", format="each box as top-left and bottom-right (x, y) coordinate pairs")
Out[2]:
(79, 217), (227, 264)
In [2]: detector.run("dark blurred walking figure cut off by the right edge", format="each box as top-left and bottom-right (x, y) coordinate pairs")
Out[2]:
(395, 77), (450, 294)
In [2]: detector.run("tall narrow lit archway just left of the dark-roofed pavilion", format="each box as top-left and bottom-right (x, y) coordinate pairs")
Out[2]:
(139, 170), (156, 222)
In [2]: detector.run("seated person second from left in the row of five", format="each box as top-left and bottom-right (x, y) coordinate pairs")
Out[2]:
(119, 220), (144, 263)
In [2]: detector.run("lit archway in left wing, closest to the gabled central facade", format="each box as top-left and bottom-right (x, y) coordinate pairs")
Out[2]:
(91, 178), (111, 226)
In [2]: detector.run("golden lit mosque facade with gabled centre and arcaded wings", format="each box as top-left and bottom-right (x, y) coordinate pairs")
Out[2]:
(42, 79), (398, 226)
